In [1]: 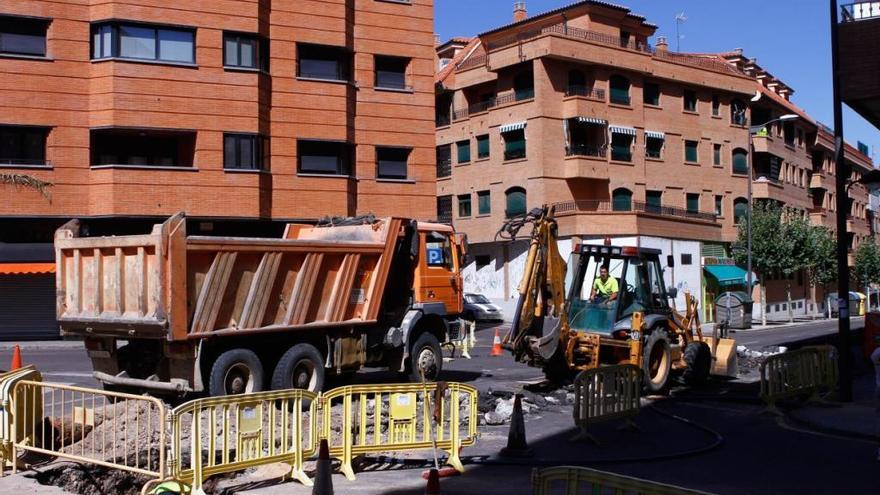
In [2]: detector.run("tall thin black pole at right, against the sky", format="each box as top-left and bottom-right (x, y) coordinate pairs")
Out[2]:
(828, 0), (852, 402)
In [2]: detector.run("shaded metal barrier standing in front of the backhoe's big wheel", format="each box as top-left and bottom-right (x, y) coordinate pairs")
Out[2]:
(572, 364), (642, 444)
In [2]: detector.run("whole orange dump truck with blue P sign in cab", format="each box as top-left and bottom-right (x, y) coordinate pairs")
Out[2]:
(55, 213), (466, 395)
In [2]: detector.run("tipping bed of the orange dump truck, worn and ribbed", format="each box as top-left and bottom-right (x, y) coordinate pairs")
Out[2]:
(55, 214), (404, 341)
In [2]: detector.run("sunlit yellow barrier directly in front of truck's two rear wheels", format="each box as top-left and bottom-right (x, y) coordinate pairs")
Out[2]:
(171, 390), (318, 494)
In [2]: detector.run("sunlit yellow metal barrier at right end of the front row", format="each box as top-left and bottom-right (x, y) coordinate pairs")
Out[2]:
(321, 383), (477, 480)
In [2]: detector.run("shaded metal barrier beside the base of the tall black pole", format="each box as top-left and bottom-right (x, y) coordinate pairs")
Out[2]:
(761, 346), (837, 414)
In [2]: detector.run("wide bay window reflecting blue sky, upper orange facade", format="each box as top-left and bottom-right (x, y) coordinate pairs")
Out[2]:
(92, 22), (196, 64)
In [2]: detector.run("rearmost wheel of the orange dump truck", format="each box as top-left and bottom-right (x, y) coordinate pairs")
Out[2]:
(208, 349), (263, 397)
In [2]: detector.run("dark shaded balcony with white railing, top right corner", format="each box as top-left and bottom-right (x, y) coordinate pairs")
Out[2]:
(838, 1), (880, 128)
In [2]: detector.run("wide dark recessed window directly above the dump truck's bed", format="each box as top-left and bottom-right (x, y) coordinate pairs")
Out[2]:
(89, 128), (196, 167)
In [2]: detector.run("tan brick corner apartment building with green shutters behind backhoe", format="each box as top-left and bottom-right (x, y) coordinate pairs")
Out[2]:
(436, 1), (872, 320)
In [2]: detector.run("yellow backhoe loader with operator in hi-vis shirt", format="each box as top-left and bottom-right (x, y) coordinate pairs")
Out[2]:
(498, 206), (736, 393)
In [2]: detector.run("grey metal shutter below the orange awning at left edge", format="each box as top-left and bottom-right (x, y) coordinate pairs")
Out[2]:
(0, 274), (60, 341)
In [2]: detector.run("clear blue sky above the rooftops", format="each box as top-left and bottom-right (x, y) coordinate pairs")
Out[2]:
(434, 0), (880, 165)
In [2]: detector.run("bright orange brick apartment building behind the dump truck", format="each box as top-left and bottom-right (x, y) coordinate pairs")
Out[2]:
(0, 0), (436, 338)
